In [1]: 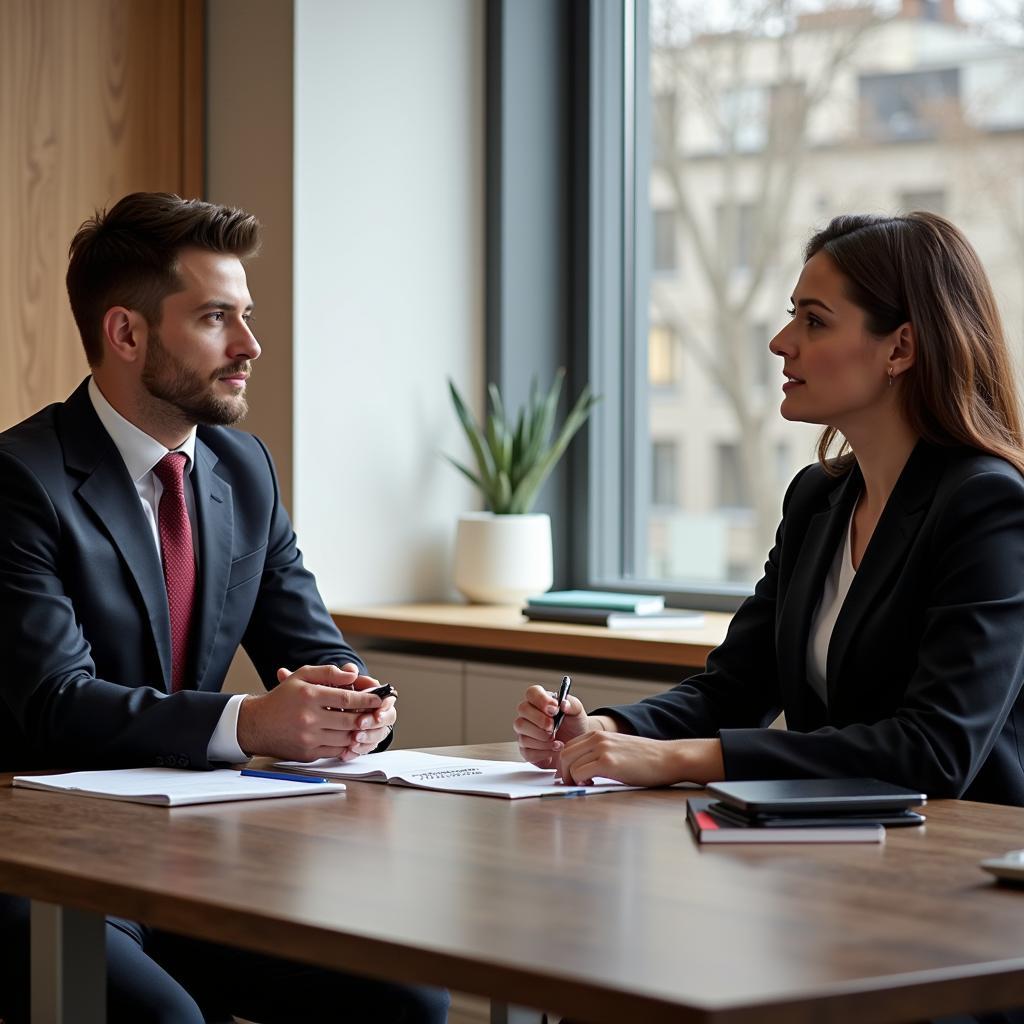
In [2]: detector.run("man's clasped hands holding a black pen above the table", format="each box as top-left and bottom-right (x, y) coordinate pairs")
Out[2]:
(238, 663), (397, 761)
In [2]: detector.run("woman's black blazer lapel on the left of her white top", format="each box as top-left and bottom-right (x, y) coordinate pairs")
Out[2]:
(776, 466), (863, 731)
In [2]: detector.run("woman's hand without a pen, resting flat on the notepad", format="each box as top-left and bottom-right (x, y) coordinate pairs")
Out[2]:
(555, 732), (725, 786)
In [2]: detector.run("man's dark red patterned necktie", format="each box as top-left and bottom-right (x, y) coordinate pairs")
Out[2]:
(153, 452), (196, 693)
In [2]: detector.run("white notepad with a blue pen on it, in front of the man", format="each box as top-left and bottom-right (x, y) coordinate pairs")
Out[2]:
(13, 768), (345, 807)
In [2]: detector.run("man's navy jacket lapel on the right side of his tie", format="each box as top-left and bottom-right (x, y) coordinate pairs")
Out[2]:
(193, 437), (234, 689)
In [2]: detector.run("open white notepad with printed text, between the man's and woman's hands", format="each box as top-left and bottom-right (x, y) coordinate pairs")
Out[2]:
(275, 751), (641, 800)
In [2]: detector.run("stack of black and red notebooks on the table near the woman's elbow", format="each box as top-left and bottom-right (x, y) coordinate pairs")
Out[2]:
(686, 778), (927, 843)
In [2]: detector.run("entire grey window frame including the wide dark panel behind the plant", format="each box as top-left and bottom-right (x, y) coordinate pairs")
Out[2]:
(487, 0), (752, 611)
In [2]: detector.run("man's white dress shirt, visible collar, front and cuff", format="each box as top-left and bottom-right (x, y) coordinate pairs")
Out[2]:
(89, 377), (249, 764)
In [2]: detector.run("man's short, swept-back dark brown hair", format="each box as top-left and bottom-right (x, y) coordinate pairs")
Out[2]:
(67, 193), (260, 367)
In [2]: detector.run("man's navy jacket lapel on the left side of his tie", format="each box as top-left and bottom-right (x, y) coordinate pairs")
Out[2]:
(57, 381), (171, 692)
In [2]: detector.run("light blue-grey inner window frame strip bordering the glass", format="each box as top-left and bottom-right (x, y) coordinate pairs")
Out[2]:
(566, 0), (753, 611)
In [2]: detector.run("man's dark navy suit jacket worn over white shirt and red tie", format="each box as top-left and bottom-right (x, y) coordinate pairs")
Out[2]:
(0, 382), (362, 770)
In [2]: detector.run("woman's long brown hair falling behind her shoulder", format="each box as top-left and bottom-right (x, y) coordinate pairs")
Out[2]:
(804, 213), (1024, 476)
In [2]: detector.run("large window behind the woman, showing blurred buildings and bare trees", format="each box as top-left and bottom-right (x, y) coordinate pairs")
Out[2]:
(589, 0), (1024, 605)
